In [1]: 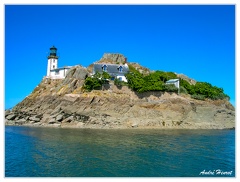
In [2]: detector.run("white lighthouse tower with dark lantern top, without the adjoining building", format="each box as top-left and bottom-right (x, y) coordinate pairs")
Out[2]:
(47, 46), (58, 77)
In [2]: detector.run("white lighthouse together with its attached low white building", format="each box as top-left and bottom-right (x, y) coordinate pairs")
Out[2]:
(46, 46), (71, 79)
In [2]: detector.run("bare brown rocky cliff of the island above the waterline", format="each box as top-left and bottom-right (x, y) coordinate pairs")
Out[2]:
(5, 55), (235, 129)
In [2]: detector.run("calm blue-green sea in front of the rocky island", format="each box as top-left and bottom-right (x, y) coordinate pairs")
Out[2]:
(5, 126), (235, 177)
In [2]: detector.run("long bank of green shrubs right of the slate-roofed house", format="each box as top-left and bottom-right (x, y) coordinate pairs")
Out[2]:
(125, 65), (230, 100)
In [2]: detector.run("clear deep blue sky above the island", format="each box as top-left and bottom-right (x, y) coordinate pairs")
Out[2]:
(5, 5), (235, 108)
